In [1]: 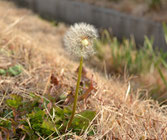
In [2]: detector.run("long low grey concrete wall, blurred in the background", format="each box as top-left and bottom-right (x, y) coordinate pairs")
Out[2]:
(14, 0), (167, 50)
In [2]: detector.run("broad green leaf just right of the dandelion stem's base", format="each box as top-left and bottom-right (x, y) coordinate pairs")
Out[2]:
(71, 110), (96, 131)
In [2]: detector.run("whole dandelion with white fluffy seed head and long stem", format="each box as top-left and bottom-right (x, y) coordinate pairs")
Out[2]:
(64, 23), (98, 129)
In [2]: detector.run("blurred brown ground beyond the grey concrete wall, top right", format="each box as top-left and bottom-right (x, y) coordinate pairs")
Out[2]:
(76, 0), (167, 23)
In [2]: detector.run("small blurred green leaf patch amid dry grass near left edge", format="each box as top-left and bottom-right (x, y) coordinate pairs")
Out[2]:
(8, 65), (23, 76)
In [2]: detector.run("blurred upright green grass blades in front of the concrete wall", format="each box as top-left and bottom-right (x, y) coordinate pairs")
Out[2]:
(95, 29), (167, 101)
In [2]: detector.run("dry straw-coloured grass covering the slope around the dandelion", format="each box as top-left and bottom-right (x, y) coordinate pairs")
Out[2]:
(0, 1), (167, 140)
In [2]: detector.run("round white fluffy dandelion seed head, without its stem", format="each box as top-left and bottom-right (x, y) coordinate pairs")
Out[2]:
(64, 23), (98, 58)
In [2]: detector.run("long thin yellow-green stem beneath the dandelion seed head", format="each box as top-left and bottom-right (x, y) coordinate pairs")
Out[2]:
(67, 57), (83, 129)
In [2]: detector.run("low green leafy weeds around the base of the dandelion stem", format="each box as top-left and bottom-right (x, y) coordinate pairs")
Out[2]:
(0, 90), (96, 140)
